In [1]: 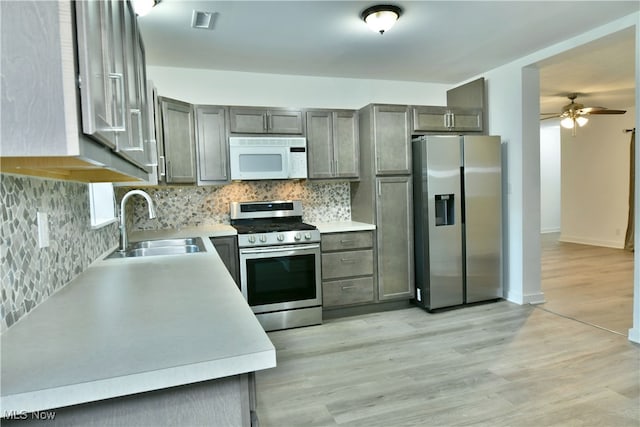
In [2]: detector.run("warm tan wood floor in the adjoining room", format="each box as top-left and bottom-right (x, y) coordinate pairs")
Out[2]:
(541, 233), (633, 336)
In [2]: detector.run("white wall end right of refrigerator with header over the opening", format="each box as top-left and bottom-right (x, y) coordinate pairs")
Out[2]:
(478, 13), (640, 308)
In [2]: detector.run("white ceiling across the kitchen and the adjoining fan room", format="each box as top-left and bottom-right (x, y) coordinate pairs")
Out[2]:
(139, 0), (640, 112)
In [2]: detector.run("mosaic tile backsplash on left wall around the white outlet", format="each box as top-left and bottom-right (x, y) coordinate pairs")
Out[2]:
(0, 174), (118, 332)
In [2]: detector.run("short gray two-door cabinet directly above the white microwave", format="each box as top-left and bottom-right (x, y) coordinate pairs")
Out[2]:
(229, 107), (304, 135)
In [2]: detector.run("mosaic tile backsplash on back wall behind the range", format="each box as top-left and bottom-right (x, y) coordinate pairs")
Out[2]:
(117, 181), (351, 230)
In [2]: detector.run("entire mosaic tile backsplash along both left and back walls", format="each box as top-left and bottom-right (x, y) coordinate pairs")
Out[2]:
(0, 174), (351, 333)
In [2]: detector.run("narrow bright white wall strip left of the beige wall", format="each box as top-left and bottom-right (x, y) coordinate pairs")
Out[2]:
(540, 122), (562, 233)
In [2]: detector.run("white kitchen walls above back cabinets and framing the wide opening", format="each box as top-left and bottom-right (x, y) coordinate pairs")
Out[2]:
(148, 13), (640, 342)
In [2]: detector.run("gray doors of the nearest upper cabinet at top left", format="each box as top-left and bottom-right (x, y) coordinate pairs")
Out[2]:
(76, 1), (151, 167)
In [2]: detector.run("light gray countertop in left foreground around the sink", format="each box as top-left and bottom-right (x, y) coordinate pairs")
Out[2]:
(0, 231), (276, 413)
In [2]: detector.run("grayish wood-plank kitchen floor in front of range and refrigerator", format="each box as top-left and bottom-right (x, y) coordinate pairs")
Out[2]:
(257, 301), (640, 427)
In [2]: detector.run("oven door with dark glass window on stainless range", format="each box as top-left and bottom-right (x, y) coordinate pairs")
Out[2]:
(240, 244), (322, 313)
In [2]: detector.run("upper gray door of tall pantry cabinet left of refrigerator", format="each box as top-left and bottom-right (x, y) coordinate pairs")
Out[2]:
(371, 105), (411, 175)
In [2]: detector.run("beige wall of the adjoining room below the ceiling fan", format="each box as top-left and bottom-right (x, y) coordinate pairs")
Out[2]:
(560, 106), (635, 248)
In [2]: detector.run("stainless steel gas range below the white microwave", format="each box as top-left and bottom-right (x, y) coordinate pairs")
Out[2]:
(231, 200), (322, 331)
